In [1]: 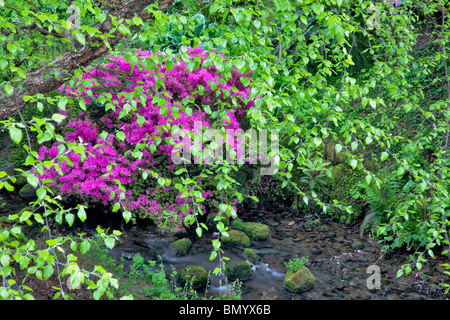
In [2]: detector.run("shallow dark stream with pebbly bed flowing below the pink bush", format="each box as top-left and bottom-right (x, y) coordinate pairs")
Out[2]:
(0, 192), (449, 300)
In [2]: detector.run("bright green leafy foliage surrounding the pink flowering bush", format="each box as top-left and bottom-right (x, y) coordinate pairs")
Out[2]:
(0, 0), (450, 299)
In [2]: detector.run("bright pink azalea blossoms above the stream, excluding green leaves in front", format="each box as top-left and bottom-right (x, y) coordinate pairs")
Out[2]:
(39, 47), (253, 231)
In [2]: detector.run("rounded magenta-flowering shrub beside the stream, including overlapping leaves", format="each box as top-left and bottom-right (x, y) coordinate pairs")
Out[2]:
(39, 47), (253, 231)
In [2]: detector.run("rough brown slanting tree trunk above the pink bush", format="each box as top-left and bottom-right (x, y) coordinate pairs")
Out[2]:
(0, 0), (174, 119)
